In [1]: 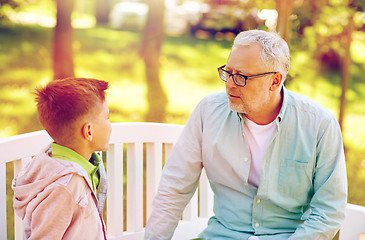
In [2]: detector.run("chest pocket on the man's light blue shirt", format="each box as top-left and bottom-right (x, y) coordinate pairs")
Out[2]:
(278, 159), (313, 205)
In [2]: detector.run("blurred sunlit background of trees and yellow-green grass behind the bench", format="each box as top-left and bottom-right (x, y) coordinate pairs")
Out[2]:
(0, 0), (365, 237)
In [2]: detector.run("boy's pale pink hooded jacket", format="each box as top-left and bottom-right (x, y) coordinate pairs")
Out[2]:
(12, 147), (106, 240)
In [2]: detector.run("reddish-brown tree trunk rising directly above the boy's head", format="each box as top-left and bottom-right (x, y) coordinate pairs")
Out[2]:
(53, 0), (74, 79)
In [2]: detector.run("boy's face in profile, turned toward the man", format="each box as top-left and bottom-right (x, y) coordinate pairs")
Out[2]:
(91, 100), (112, 151)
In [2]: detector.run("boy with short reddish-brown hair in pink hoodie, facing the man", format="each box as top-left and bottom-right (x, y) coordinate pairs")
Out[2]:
(12, 78), (111, 239)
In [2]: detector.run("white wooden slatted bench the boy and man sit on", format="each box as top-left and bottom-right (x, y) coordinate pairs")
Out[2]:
(0, 123), (365, 240)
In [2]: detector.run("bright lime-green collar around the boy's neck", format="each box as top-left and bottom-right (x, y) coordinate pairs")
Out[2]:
(51, 142), (100, 175)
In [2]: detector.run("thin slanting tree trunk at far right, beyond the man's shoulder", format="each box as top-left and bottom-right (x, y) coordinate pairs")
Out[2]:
(338, 13), (354, 131)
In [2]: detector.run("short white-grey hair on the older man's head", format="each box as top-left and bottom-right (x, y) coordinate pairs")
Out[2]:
(232, 30), (290, 80)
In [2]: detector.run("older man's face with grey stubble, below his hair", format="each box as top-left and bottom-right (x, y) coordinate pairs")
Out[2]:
(226, 44), (272, 118)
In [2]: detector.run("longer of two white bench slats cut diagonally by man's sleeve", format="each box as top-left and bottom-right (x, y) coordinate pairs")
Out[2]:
(146, 143), (162, 221)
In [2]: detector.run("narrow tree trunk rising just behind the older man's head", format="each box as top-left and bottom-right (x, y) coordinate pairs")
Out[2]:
(276, 0), (293, 44)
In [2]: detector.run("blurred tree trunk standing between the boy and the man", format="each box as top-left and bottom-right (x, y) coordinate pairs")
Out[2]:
(141, 0), (168, 122)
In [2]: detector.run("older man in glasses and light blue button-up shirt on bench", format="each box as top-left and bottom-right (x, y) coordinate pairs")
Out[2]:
(145, 30), (347, 240)
